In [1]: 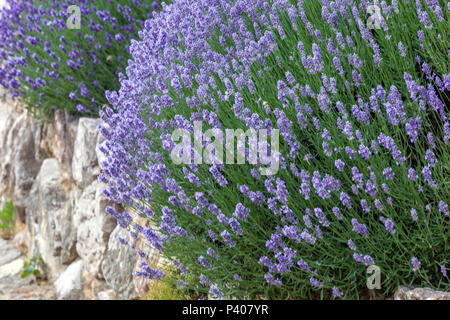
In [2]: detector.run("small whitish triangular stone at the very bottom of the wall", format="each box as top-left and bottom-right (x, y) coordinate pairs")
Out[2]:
(54, 260), (83, 300)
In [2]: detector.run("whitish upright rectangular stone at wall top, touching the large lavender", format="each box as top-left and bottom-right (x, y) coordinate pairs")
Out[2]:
(72, 118), (102, 188)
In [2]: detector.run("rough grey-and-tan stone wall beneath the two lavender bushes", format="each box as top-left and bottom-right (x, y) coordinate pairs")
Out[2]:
(0, 92), (146, 299)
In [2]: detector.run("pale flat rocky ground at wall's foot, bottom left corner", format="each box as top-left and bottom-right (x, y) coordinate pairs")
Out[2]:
(0, 238), (54, 300)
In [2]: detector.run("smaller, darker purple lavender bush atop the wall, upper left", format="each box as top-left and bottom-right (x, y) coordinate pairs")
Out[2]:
(0, 0), (159, 118)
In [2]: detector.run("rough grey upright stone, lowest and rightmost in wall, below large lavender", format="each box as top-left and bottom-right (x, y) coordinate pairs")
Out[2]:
(102, 226), (138, 300)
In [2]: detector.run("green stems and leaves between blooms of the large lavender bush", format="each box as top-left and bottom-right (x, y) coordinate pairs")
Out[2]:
(125, 1), (450, 299)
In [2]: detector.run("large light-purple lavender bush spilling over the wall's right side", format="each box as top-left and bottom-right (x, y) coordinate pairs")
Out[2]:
(99, 0), (450, 299)
